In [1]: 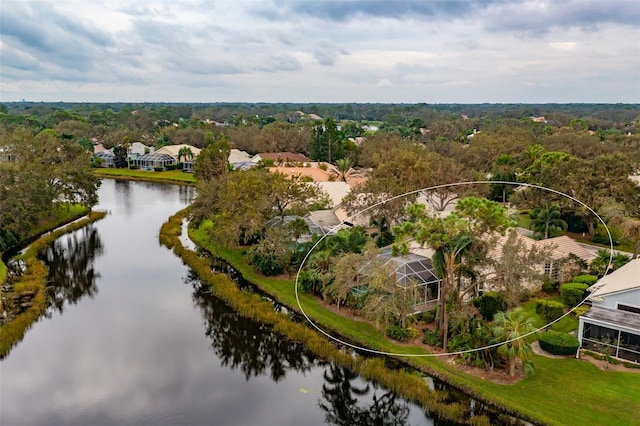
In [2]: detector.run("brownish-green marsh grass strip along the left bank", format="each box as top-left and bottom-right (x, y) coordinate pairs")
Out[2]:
(0, 207), (107, 359)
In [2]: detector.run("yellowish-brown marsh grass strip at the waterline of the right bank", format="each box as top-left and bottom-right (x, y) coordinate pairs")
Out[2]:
(159, 209), (500, 425)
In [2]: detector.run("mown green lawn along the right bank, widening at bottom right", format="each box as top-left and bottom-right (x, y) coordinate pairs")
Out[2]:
(191, 223), (640, 425)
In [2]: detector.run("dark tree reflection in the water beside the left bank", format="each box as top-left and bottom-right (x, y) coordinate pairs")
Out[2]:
(38, 225), (103, 313)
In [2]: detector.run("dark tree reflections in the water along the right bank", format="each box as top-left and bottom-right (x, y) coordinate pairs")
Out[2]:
(185, 271), (418, 426)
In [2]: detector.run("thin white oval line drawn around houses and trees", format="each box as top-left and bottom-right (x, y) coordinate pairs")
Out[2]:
(294, 180), (614, 357)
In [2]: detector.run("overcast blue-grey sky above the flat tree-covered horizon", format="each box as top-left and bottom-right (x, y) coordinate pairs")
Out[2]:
(0, 0), (640, 103)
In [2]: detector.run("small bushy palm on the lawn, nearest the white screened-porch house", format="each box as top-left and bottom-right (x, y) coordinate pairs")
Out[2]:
(493, 310), (535, 377)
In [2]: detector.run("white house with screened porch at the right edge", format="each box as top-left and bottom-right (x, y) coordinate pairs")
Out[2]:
(578, 258), (640, 363)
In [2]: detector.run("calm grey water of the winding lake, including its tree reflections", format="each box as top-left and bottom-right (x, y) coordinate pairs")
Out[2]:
(0, 180), (443, 426)
